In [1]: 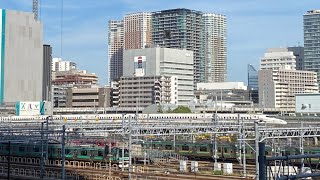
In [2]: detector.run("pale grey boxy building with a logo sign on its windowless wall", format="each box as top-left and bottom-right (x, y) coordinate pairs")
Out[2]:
(123, 47), (194, 105)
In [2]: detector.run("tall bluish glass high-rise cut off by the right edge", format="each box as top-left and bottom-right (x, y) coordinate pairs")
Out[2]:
(303, 10), (320, 84)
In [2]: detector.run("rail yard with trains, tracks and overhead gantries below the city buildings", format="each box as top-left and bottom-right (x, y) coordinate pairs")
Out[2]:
(0, 114), (320, 179)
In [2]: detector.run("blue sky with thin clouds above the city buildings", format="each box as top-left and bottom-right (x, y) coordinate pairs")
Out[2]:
(0, 0), (320, 85)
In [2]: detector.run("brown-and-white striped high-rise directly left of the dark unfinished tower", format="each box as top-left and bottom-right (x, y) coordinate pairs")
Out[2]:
(123, 12), (152, 49)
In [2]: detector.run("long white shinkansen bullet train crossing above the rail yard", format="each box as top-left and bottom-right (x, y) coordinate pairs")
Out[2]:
(0, 113), (287, 125)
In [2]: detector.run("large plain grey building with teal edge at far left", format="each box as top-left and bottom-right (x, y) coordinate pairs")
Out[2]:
(0, 9), (44, 104)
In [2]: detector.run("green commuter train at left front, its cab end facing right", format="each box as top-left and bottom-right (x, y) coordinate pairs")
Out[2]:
(0, 143), (129, 165)
